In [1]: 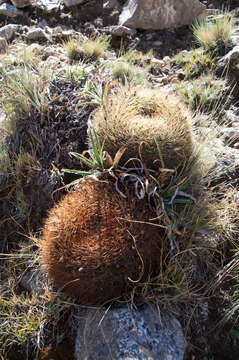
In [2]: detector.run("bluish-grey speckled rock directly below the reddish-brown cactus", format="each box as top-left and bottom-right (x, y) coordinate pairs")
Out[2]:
(75, 303), (186, 360)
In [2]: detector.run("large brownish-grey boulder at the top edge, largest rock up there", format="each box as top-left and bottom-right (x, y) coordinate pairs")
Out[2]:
(119, 0), (206, 30)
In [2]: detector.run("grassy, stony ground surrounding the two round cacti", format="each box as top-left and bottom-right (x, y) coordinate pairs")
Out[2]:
(0, 0), (239, 360)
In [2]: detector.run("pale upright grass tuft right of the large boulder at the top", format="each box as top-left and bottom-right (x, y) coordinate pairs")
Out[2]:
(192, 12), (235, 49)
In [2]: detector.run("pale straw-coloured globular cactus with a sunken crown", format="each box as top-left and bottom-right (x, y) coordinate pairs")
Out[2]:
(89, 87), (193, 169)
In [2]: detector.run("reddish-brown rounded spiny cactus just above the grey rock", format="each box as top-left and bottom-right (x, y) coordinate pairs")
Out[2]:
(41, 179), (164, 305)
